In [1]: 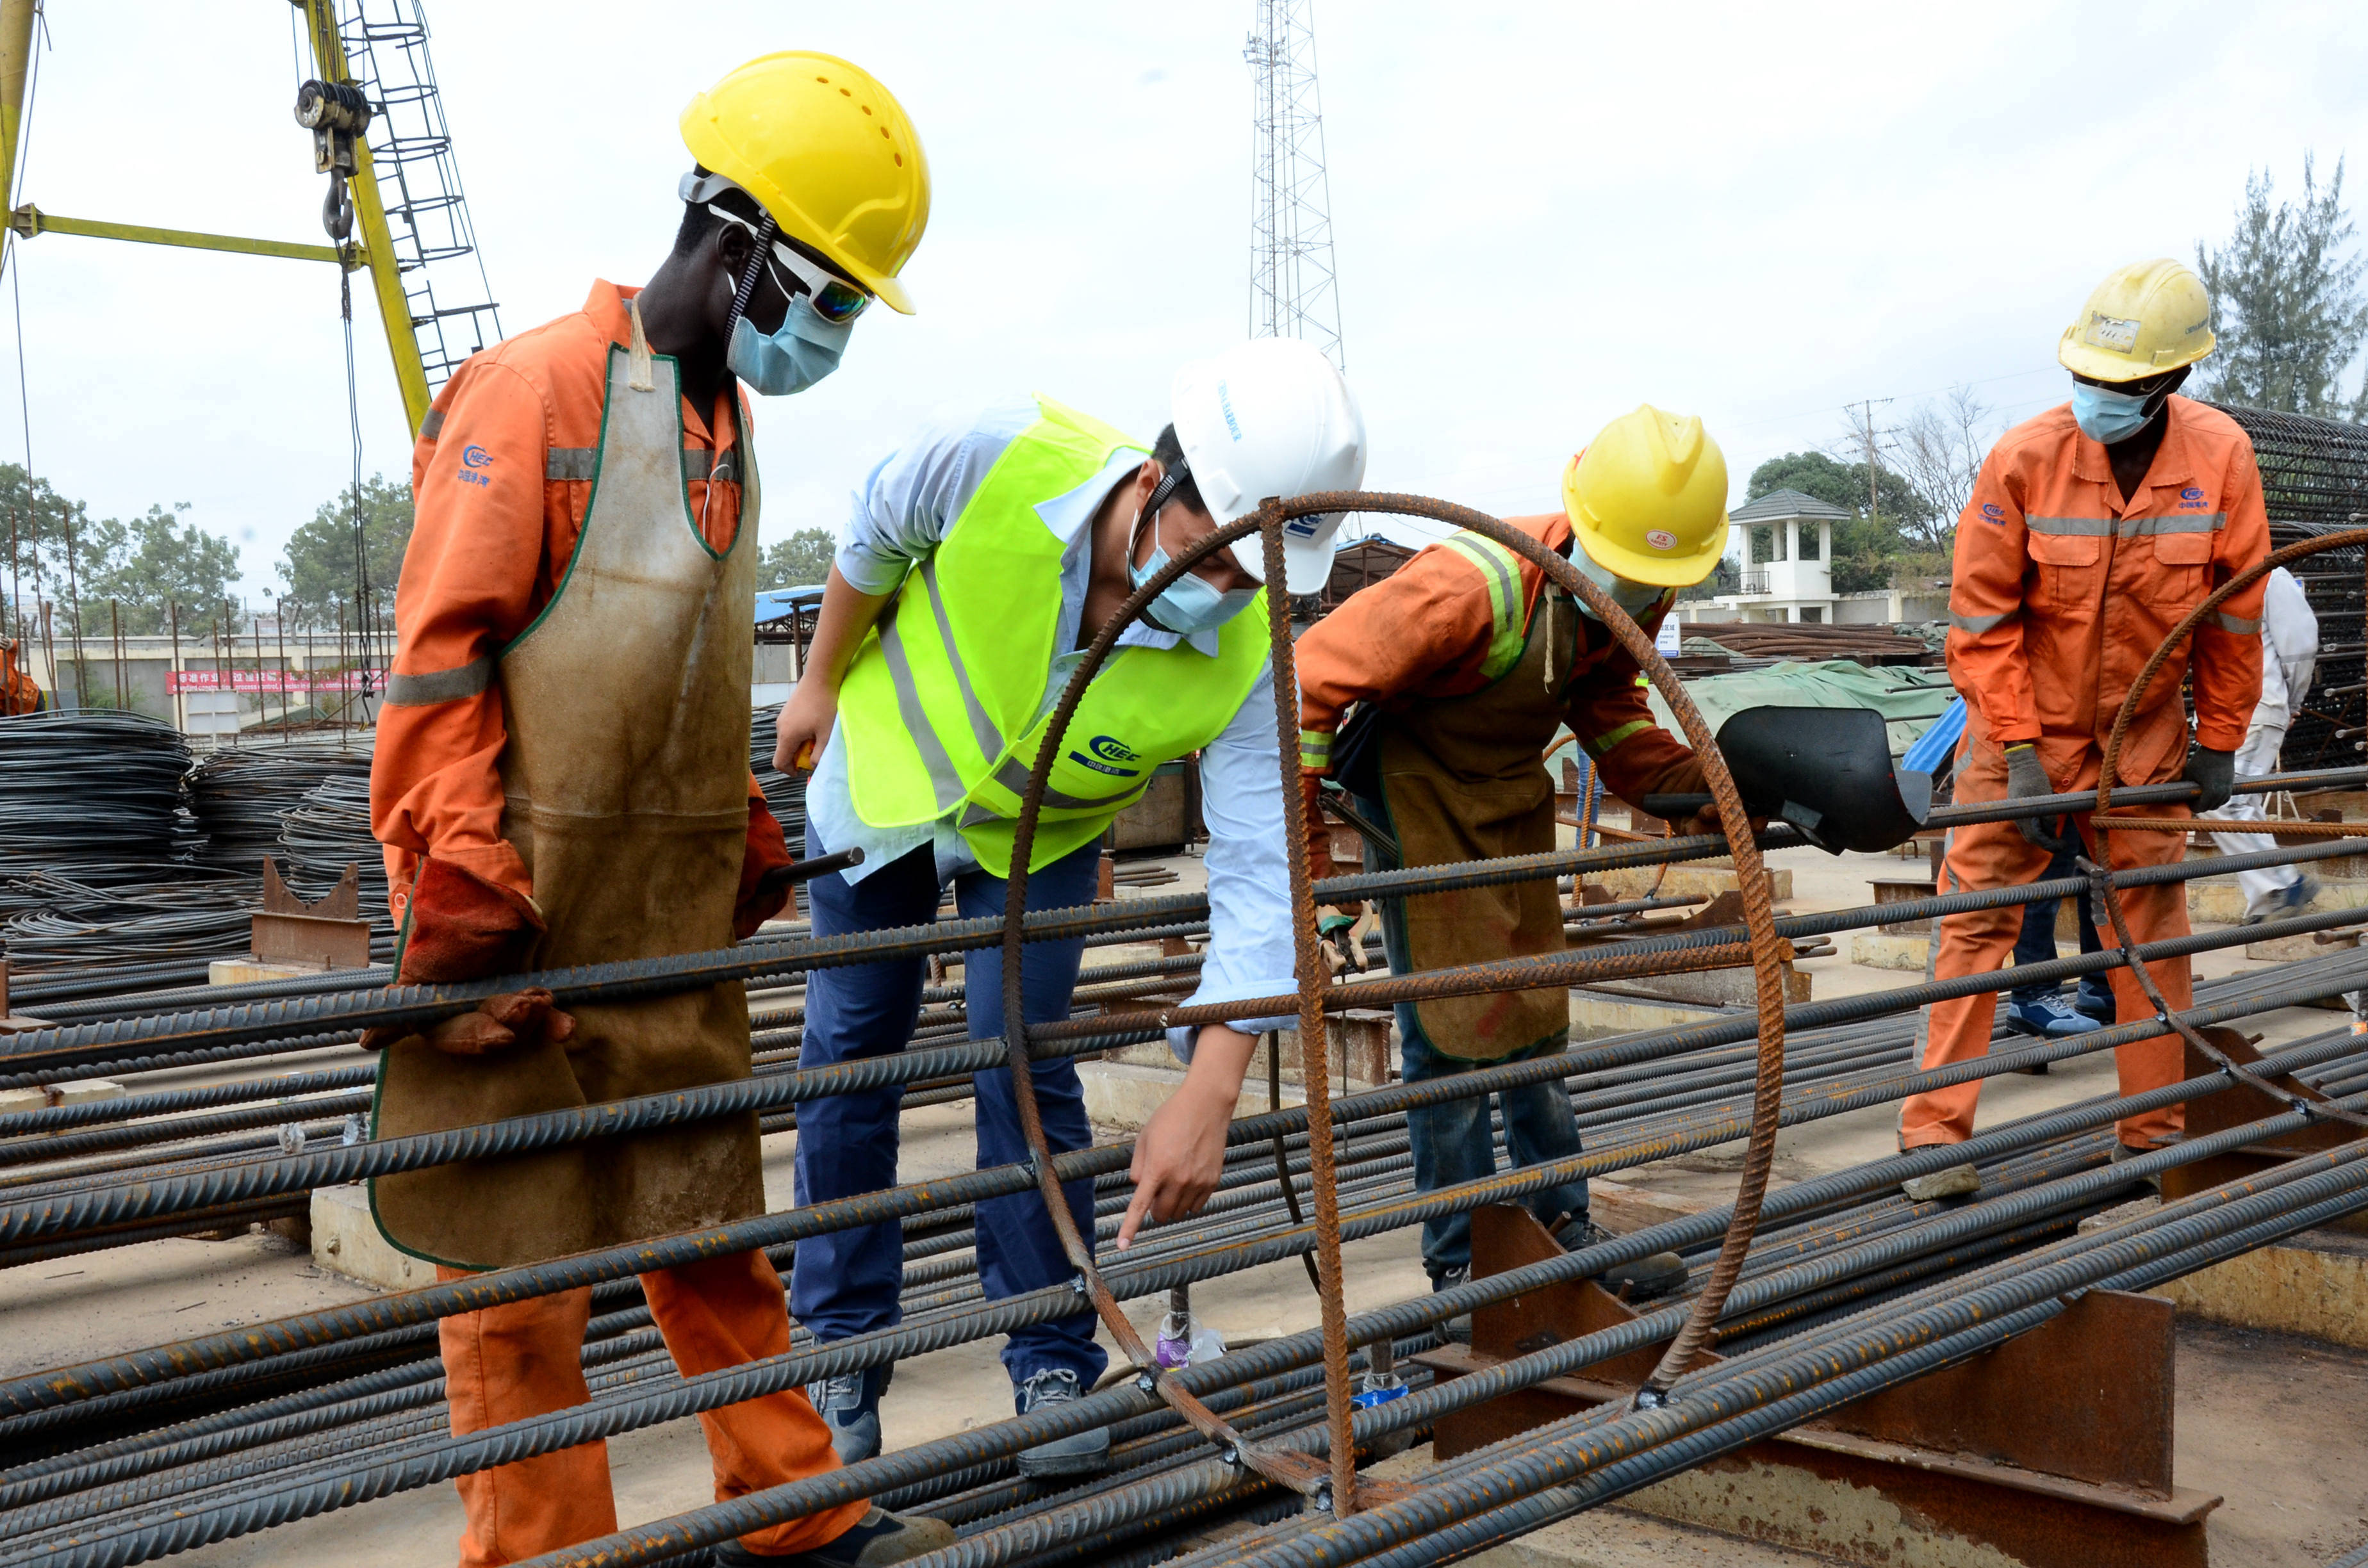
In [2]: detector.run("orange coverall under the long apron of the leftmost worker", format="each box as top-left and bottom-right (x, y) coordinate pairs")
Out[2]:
(370, 282), (867, 1568)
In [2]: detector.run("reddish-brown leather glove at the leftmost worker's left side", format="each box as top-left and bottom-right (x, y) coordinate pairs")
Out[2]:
(362, 855), (575, 1056)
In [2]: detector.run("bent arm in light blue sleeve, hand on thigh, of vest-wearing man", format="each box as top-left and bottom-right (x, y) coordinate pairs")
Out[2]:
(772, 403), (1037, 772)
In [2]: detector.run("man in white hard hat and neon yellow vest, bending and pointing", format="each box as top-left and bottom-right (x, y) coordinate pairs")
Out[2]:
(775, 339), (1364, 1476)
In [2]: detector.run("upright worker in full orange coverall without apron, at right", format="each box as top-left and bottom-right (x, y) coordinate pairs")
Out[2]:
(1899, 261), (2269, 1175)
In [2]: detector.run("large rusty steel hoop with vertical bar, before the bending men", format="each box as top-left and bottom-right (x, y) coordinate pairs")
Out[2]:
(1001, 490), (1783, 1514)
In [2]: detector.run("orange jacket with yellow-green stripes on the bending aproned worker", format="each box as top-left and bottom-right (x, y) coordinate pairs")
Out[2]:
(1297, 512), (1702, 879)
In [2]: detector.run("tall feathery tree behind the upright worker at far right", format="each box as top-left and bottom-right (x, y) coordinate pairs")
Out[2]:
(2192, 154), (2368, 420)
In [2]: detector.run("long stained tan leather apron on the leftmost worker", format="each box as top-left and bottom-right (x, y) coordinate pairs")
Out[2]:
(372, 334), (765, 1267)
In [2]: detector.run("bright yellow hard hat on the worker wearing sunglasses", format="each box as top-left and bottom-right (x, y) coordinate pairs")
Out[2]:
(682, 50), (928, 315)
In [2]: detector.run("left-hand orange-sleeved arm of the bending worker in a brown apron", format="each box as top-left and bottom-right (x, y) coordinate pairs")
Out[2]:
(1290, 545), (1527, 881)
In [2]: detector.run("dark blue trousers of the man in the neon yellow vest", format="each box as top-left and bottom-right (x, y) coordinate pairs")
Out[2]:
(789, 831), (1108, 1388)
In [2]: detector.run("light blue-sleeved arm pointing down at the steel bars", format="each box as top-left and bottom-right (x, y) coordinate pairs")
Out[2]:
(1118, 666), (1297, 1246)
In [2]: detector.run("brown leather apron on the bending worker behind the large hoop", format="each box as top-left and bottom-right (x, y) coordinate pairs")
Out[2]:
(1381, 583), (1577, 1061)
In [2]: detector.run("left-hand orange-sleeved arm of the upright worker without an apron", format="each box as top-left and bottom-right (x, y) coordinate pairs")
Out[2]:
(1946, 448), (2036, 749)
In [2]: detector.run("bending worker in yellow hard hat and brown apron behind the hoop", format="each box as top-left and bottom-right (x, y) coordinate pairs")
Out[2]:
(1297, 405), (1726, 1326)
